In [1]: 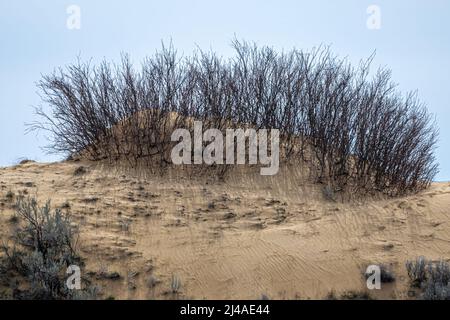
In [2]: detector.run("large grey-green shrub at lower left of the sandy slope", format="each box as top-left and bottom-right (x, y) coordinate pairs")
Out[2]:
(1, 198), (96, 299)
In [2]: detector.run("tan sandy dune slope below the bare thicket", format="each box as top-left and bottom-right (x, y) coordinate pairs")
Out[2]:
(0, 162), (450, 299)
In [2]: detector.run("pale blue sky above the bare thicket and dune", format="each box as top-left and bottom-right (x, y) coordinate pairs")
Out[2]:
(0, 0), (450, 180)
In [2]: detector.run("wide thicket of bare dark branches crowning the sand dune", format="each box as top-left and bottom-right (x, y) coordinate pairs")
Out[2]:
(35, 41), (437, 194)
